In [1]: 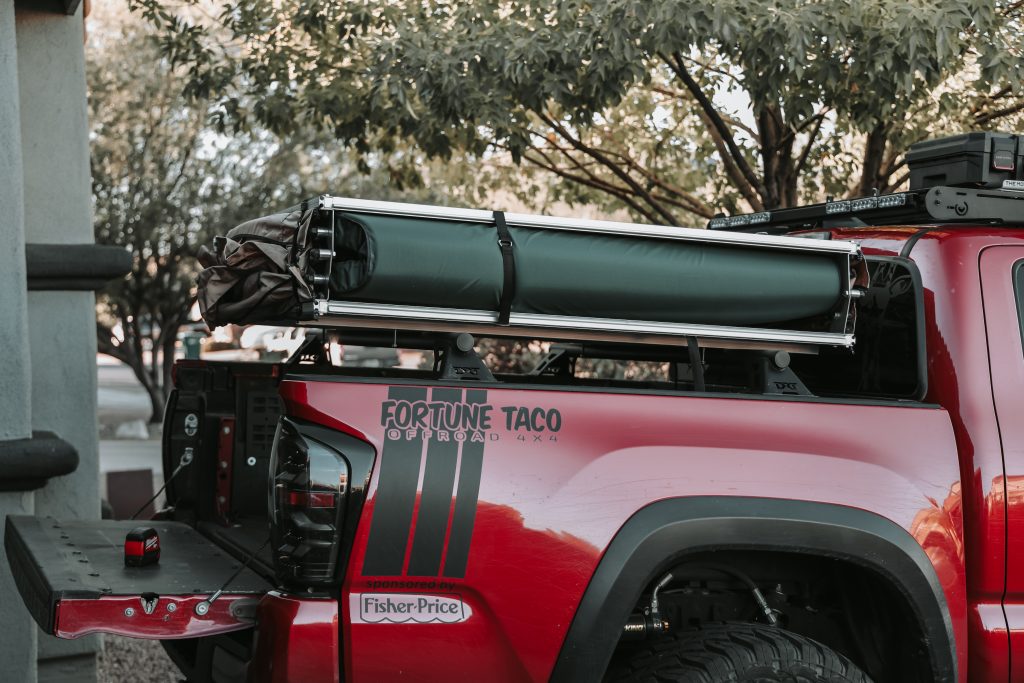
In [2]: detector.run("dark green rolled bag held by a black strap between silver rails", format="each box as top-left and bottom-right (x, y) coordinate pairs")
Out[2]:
(330, 211), (849, 326)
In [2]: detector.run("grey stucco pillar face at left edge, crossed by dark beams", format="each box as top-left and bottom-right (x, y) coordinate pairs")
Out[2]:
(15, 0), (99, 682)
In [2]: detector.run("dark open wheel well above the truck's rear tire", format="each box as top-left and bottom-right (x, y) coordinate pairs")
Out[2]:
(613, 550), (933, 683)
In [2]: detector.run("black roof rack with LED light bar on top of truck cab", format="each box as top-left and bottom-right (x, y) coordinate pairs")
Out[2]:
(708, 186), (1024, 234)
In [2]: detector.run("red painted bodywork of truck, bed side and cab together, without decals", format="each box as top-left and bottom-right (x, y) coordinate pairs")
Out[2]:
(253, 226), (1024, 681)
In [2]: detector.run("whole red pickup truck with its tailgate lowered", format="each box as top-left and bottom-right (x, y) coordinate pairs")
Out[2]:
(5, 136), (1024, 683)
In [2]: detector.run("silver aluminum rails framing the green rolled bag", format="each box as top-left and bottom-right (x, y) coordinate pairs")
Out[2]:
(302, 195), (860, 352)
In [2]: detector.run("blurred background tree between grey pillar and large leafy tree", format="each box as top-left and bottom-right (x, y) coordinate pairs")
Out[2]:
(87, 6), (468, 422)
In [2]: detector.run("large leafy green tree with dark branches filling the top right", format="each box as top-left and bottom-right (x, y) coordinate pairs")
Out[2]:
(132, 0), (1024, 223)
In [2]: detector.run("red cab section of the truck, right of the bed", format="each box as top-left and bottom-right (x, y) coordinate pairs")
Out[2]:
(836, 226), (1024, 681)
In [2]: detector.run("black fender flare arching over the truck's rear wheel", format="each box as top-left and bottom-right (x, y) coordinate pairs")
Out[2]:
(551, 497), (957, 683)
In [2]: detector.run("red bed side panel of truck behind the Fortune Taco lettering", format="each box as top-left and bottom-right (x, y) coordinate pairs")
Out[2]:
(282, 379), (967, 681)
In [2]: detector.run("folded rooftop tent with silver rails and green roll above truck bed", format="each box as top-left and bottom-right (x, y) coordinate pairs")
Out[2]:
(193, 196), (862, 346)
